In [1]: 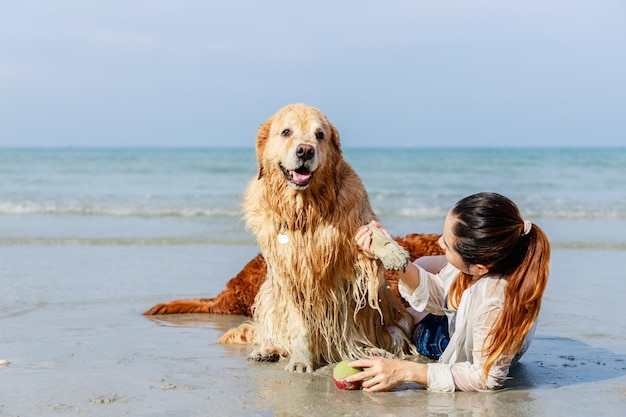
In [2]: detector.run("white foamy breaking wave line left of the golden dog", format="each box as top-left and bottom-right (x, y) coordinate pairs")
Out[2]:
(0, 202), (241, 217)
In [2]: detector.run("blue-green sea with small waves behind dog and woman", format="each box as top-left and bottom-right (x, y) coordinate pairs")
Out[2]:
(0, 148), (626, 250)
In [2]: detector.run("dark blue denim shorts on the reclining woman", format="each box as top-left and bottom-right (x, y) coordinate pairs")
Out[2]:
(411, 314), (450, 359)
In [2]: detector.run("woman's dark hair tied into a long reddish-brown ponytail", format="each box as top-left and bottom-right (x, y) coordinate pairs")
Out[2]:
(448, 193), (550, 382)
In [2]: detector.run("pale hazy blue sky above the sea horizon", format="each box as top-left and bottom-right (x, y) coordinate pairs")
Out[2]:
(0, 0), (626, 147)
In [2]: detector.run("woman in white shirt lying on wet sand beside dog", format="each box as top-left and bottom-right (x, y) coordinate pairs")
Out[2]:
(349, 193), (550, 392)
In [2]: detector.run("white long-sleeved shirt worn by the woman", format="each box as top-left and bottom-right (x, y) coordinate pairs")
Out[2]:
(398, 263), (534, 392)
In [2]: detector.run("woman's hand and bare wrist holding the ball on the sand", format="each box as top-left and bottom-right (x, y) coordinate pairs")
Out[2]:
(346, 357), (428, 392)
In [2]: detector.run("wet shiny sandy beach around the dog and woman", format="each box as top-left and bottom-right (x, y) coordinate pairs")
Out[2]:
(0, 240), (626, 416)
